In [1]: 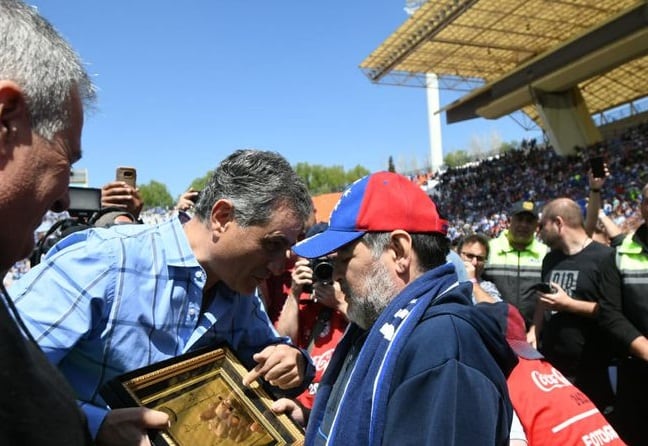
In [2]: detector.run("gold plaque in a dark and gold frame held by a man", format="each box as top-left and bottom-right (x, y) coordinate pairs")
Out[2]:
(101, 347), (304, 446)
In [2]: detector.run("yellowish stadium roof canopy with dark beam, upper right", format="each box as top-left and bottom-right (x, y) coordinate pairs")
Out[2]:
(360, 0), (648, 127)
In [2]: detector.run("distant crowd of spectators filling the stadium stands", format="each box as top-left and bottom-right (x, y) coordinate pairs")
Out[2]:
(4, 123), (648, 285)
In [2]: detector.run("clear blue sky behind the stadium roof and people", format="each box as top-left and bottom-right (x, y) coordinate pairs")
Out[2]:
(27, 0), (539, 197)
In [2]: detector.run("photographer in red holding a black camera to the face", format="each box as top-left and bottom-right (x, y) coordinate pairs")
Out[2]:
(275, 223), (347, 409)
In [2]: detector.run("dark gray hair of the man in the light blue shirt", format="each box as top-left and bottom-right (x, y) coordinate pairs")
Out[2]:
(196, 149), (313, 227)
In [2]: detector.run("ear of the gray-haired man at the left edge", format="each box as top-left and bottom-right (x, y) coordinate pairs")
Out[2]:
(0, 80), (31, 146)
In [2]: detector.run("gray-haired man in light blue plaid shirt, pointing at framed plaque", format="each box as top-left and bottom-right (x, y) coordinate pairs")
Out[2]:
(14, 150), (314, 445)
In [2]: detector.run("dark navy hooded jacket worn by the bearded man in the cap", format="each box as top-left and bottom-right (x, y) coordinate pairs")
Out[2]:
(306, 266), (517, 446)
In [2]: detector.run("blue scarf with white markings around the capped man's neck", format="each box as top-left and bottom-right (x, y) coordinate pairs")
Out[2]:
(306, 263), (469, 445)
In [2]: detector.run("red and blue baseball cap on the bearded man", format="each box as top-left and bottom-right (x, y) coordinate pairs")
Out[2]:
(293, 172), (448, 259)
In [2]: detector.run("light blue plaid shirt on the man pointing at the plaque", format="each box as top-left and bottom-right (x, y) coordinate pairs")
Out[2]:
(12, 218), (296, 436)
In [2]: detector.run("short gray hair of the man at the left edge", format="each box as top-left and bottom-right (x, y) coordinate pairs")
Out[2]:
(0, 0), (96, 140)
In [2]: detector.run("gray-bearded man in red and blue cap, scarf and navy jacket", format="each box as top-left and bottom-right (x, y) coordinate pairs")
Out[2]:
(274, 172), (515, 445)
